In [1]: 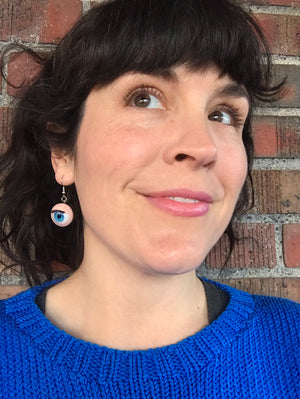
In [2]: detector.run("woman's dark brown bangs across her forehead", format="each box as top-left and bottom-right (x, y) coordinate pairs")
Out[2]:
(73, 0), (266, 102)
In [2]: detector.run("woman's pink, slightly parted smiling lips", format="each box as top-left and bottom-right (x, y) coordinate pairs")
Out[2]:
(144, 189), (212, 217)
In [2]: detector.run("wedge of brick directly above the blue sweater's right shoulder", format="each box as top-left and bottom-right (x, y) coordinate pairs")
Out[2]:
(219, 277), (300, 302)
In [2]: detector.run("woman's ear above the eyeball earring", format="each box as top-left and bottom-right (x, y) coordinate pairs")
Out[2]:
(51, 151), (75, 186)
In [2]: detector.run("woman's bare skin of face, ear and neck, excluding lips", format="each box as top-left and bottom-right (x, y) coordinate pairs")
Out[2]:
(46, 66), (249, 350)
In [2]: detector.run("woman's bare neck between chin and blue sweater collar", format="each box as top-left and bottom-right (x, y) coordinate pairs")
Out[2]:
(46, 262), (208, 350)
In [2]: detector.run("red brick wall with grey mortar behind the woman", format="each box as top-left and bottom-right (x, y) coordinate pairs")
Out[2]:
(0, 0), (300, 301)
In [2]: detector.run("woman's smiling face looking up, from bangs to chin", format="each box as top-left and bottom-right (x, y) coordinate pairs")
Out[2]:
(63, 67), (248, 274)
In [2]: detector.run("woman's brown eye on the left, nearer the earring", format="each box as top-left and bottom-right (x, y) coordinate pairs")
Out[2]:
(125, 87), (164, 109)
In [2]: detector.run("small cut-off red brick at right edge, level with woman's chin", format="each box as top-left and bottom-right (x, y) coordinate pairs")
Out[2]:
(283, 224), (300, 267)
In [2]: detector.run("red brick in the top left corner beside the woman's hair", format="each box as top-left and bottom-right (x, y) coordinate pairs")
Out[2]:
(0, 0), (81, 43)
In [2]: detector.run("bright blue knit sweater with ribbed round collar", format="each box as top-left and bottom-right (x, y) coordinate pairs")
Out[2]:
(0, 285), (300, 399)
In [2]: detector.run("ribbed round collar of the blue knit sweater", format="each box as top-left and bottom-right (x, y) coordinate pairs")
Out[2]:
(5, 282), (254, 383)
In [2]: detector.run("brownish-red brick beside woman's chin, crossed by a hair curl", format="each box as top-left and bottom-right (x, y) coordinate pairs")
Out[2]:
(206, 223), (276, 269)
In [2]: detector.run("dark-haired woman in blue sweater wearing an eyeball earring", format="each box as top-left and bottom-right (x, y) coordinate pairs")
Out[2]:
(0, 0), (299, 398)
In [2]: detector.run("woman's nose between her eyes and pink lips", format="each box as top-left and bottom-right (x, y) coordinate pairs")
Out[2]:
(163, 117), (217, 167)
